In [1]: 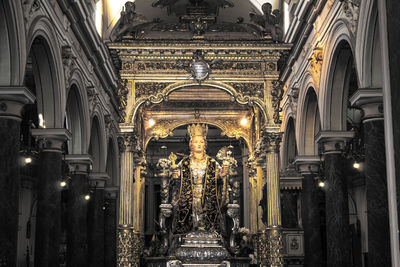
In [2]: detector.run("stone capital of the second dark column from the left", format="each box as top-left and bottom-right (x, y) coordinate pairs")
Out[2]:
(32, 128), (72, 153)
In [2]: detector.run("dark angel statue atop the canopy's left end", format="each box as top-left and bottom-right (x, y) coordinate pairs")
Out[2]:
(110, 1), (147, 42)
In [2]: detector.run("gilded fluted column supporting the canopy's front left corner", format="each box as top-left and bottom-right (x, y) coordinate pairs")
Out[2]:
(117, 131), (139, 267)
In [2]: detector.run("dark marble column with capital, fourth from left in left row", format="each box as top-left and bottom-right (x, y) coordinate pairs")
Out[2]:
(88, 172), (109, 267)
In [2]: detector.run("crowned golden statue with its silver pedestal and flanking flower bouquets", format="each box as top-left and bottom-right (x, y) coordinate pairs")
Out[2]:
(159, 124), (239, 262)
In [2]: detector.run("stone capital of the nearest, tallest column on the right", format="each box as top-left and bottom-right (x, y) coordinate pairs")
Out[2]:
(349, 88), (383, 122)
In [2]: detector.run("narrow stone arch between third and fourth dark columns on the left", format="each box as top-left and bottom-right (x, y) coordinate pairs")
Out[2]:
(88, 110), (107, 172)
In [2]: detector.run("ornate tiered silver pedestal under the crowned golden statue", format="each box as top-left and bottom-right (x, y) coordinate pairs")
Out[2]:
(171, 231), (230, 267)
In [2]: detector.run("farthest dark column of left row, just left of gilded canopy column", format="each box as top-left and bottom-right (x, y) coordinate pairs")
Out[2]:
(104, 187), (119, 266)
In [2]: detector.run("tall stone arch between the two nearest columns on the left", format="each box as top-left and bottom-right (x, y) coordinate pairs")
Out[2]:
(28, 17), (66, 128)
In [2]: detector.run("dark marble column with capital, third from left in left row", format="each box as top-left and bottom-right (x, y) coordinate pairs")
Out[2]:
(65, 155), (93, 267)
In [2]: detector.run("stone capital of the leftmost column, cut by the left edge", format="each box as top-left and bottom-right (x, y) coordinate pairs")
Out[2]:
(0, 86), (35, 120)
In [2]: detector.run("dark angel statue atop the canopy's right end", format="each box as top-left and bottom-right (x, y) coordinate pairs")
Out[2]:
(249, 3), (283, 41)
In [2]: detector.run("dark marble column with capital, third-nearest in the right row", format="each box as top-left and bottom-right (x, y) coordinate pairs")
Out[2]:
(295, 156), (323, 267)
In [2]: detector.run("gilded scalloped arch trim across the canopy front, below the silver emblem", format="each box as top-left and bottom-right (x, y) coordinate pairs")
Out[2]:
(127, 81), (272, 125)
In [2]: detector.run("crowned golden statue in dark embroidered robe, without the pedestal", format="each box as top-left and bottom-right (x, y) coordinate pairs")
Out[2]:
(170, 124), (228, 234)
